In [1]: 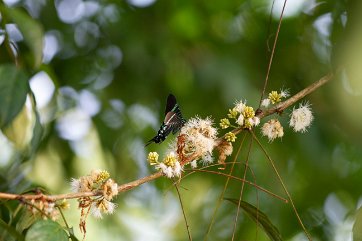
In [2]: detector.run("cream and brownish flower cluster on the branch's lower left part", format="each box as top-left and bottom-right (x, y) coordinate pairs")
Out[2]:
(71, 170), (118, 218)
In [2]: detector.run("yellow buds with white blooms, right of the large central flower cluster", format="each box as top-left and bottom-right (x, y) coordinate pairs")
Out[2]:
(220, 101), (260, 133)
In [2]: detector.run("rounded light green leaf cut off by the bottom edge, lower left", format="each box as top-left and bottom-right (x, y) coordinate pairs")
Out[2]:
(25, 220), (68, 241)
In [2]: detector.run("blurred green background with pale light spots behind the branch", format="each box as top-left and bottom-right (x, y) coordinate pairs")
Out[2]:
(0, 0), (362, 241)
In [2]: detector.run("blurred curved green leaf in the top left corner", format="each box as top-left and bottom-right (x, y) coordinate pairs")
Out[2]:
(0, 6), (44, 68)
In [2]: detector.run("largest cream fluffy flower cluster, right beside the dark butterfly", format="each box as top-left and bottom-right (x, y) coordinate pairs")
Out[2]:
(147, 117), (221, 178)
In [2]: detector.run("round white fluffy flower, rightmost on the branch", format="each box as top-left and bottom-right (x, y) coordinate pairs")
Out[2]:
(289, 103), (313, 132)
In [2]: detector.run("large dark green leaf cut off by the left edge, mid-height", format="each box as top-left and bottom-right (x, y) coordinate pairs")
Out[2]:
(0, 65), (29, 128)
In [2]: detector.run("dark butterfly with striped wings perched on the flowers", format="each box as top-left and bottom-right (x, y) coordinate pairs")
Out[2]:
(146, 94), (186, 146)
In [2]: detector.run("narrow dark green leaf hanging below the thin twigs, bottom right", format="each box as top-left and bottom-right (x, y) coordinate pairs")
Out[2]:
(224, 198), (282, 241)
